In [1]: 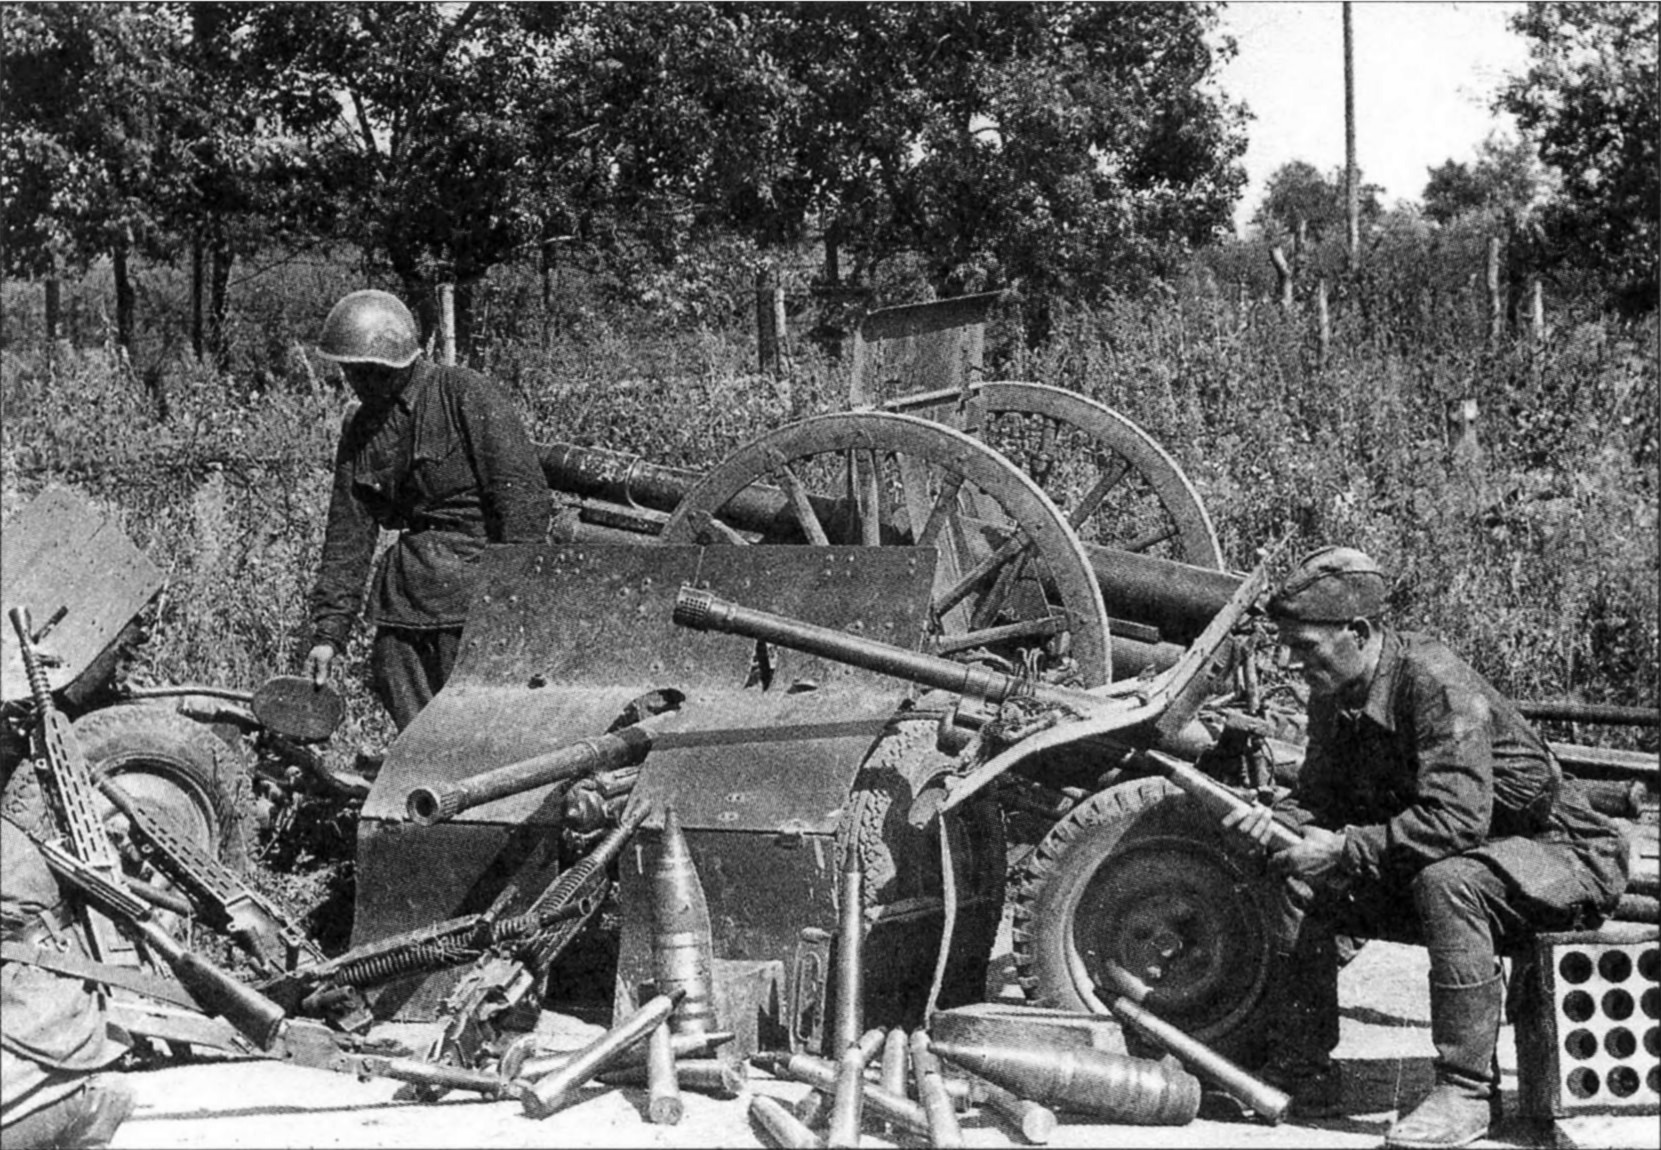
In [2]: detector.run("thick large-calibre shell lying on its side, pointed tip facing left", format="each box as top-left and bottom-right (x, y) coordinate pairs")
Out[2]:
(912, 1037), (1199, 1125)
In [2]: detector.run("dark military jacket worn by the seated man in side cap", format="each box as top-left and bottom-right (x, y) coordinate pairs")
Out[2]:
(1279, 628), (1628, 924)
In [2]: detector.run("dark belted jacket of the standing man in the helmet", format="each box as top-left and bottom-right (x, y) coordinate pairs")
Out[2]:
(311, 359), (550, 650)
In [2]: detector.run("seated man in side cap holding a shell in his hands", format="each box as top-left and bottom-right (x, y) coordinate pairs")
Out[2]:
(1226, 547), (1628, 1150)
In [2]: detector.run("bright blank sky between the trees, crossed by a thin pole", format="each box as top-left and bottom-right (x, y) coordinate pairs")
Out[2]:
(1219, 0), (1528, 231)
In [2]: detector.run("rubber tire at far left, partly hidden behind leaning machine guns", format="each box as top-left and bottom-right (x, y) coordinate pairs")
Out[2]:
(75, 703), (247, 871)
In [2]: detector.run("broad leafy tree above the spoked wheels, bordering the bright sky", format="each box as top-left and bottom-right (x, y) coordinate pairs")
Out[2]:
(750, 3), (1246, 322)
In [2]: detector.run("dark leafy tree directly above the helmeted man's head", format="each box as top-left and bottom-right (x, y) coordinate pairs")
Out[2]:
(236, 3), (573, 346)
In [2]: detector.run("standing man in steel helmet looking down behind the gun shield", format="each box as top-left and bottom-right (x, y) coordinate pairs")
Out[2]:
(306, 291), (550, 730)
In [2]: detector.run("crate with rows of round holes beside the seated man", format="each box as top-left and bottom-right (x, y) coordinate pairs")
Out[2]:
(1515, 922), (1661, 1118)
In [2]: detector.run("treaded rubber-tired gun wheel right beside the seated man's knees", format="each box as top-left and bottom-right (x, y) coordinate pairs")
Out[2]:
(1013, 778), (1274, 1065)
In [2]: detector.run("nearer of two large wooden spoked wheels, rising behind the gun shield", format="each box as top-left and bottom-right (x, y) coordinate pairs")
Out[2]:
(663, 412), (1113, 686)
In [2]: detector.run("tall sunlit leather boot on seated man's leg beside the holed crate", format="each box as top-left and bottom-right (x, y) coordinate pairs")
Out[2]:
(1384, 976), (1505, 1150)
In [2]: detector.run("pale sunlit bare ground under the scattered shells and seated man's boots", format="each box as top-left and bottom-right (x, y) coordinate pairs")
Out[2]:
(113, 936), (1658, 1150)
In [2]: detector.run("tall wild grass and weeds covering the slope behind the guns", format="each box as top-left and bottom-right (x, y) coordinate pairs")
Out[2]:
(0, 231), (1658, 746)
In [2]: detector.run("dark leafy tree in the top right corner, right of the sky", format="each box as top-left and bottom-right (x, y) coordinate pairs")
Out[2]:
(1495, 3), (1661, 312)
